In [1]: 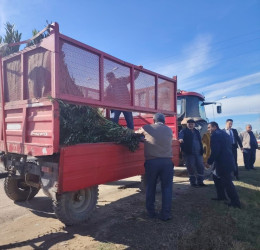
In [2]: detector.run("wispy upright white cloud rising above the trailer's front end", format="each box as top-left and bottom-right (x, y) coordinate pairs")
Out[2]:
(155, 35), (216, 88)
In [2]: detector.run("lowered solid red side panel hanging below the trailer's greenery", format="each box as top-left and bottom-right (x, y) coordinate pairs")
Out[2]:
(59, 140), (179, 193)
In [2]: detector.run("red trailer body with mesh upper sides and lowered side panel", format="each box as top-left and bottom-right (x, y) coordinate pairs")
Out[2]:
(0, 23), (179, 192)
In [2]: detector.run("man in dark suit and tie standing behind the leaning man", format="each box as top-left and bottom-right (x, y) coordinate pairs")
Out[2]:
(223, 119), (243, 180)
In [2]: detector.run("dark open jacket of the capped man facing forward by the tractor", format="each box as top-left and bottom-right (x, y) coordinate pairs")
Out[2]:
(179, 128), (203, 155)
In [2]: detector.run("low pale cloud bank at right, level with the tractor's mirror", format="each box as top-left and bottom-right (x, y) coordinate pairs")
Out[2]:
(205, 94), (260, 118)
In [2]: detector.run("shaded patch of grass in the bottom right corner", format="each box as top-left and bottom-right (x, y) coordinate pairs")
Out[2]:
(178, 165), (260, 250)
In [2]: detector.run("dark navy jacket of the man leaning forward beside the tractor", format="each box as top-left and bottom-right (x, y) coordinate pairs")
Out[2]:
(208, 129), (235, 176)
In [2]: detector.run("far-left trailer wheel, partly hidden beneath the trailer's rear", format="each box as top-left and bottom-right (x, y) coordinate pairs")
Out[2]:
(4, 177), (40, 201)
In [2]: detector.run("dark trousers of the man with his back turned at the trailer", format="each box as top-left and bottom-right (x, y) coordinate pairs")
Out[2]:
(144, 158), (174, 219)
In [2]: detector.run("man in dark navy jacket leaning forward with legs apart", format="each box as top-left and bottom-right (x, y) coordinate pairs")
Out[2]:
(208, 122), (241, 208)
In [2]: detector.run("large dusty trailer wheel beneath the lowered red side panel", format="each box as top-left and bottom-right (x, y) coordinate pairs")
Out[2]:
(53, 186), (98, 226)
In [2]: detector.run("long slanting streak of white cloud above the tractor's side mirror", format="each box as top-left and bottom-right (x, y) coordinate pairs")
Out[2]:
(198, 72), (260, 100)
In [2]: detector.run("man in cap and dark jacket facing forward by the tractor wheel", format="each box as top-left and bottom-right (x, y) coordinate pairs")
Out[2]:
(179, 119), (206, 187)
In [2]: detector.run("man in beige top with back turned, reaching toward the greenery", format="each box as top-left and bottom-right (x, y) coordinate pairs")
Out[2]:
(137, 113), (174, 221)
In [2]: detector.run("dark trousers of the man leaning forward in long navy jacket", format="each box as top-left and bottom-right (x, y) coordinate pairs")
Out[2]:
(213, 174), (240, 206)
